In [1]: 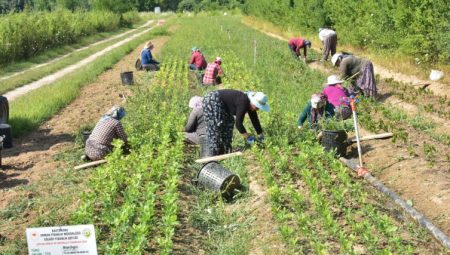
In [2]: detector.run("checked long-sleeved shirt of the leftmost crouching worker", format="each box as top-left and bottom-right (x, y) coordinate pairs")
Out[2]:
(89, 118), (127, 147)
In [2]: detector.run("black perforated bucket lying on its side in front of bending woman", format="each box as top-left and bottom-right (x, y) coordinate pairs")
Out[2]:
(197, 161), (241, 196)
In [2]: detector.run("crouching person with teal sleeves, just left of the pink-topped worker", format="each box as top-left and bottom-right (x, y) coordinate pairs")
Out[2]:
(297, 94), (334, 129)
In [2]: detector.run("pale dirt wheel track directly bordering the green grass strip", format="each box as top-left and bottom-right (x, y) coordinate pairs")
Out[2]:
(3, 20), (161, 102)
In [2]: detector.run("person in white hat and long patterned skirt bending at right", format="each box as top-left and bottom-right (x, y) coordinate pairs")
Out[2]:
(331, 53), (377, 97)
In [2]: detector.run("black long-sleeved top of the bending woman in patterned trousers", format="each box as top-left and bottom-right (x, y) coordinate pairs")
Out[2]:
(219, 89), (263, 134)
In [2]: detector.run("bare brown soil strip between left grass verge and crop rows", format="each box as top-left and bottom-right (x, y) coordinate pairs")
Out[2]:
(0, 37), (167, 210)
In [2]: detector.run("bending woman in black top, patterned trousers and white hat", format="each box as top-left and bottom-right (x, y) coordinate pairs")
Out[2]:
(203, 89), (269, 156)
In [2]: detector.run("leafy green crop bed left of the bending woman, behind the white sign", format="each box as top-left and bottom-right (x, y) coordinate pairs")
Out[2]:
(73, 60), (187, 254)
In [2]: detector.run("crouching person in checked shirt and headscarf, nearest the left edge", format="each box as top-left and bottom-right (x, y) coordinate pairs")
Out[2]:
(85, 106), (128, 160)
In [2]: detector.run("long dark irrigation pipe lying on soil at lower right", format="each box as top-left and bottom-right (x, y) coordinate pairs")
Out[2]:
(339, 157), (450, 250)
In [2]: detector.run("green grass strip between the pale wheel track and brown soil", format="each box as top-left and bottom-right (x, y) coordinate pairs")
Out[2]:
(10, 24), (164, 137)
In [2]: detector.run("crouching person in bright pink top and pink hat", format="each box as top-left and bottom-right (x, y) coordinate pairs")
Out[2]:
(322, 75), (352, 120)
